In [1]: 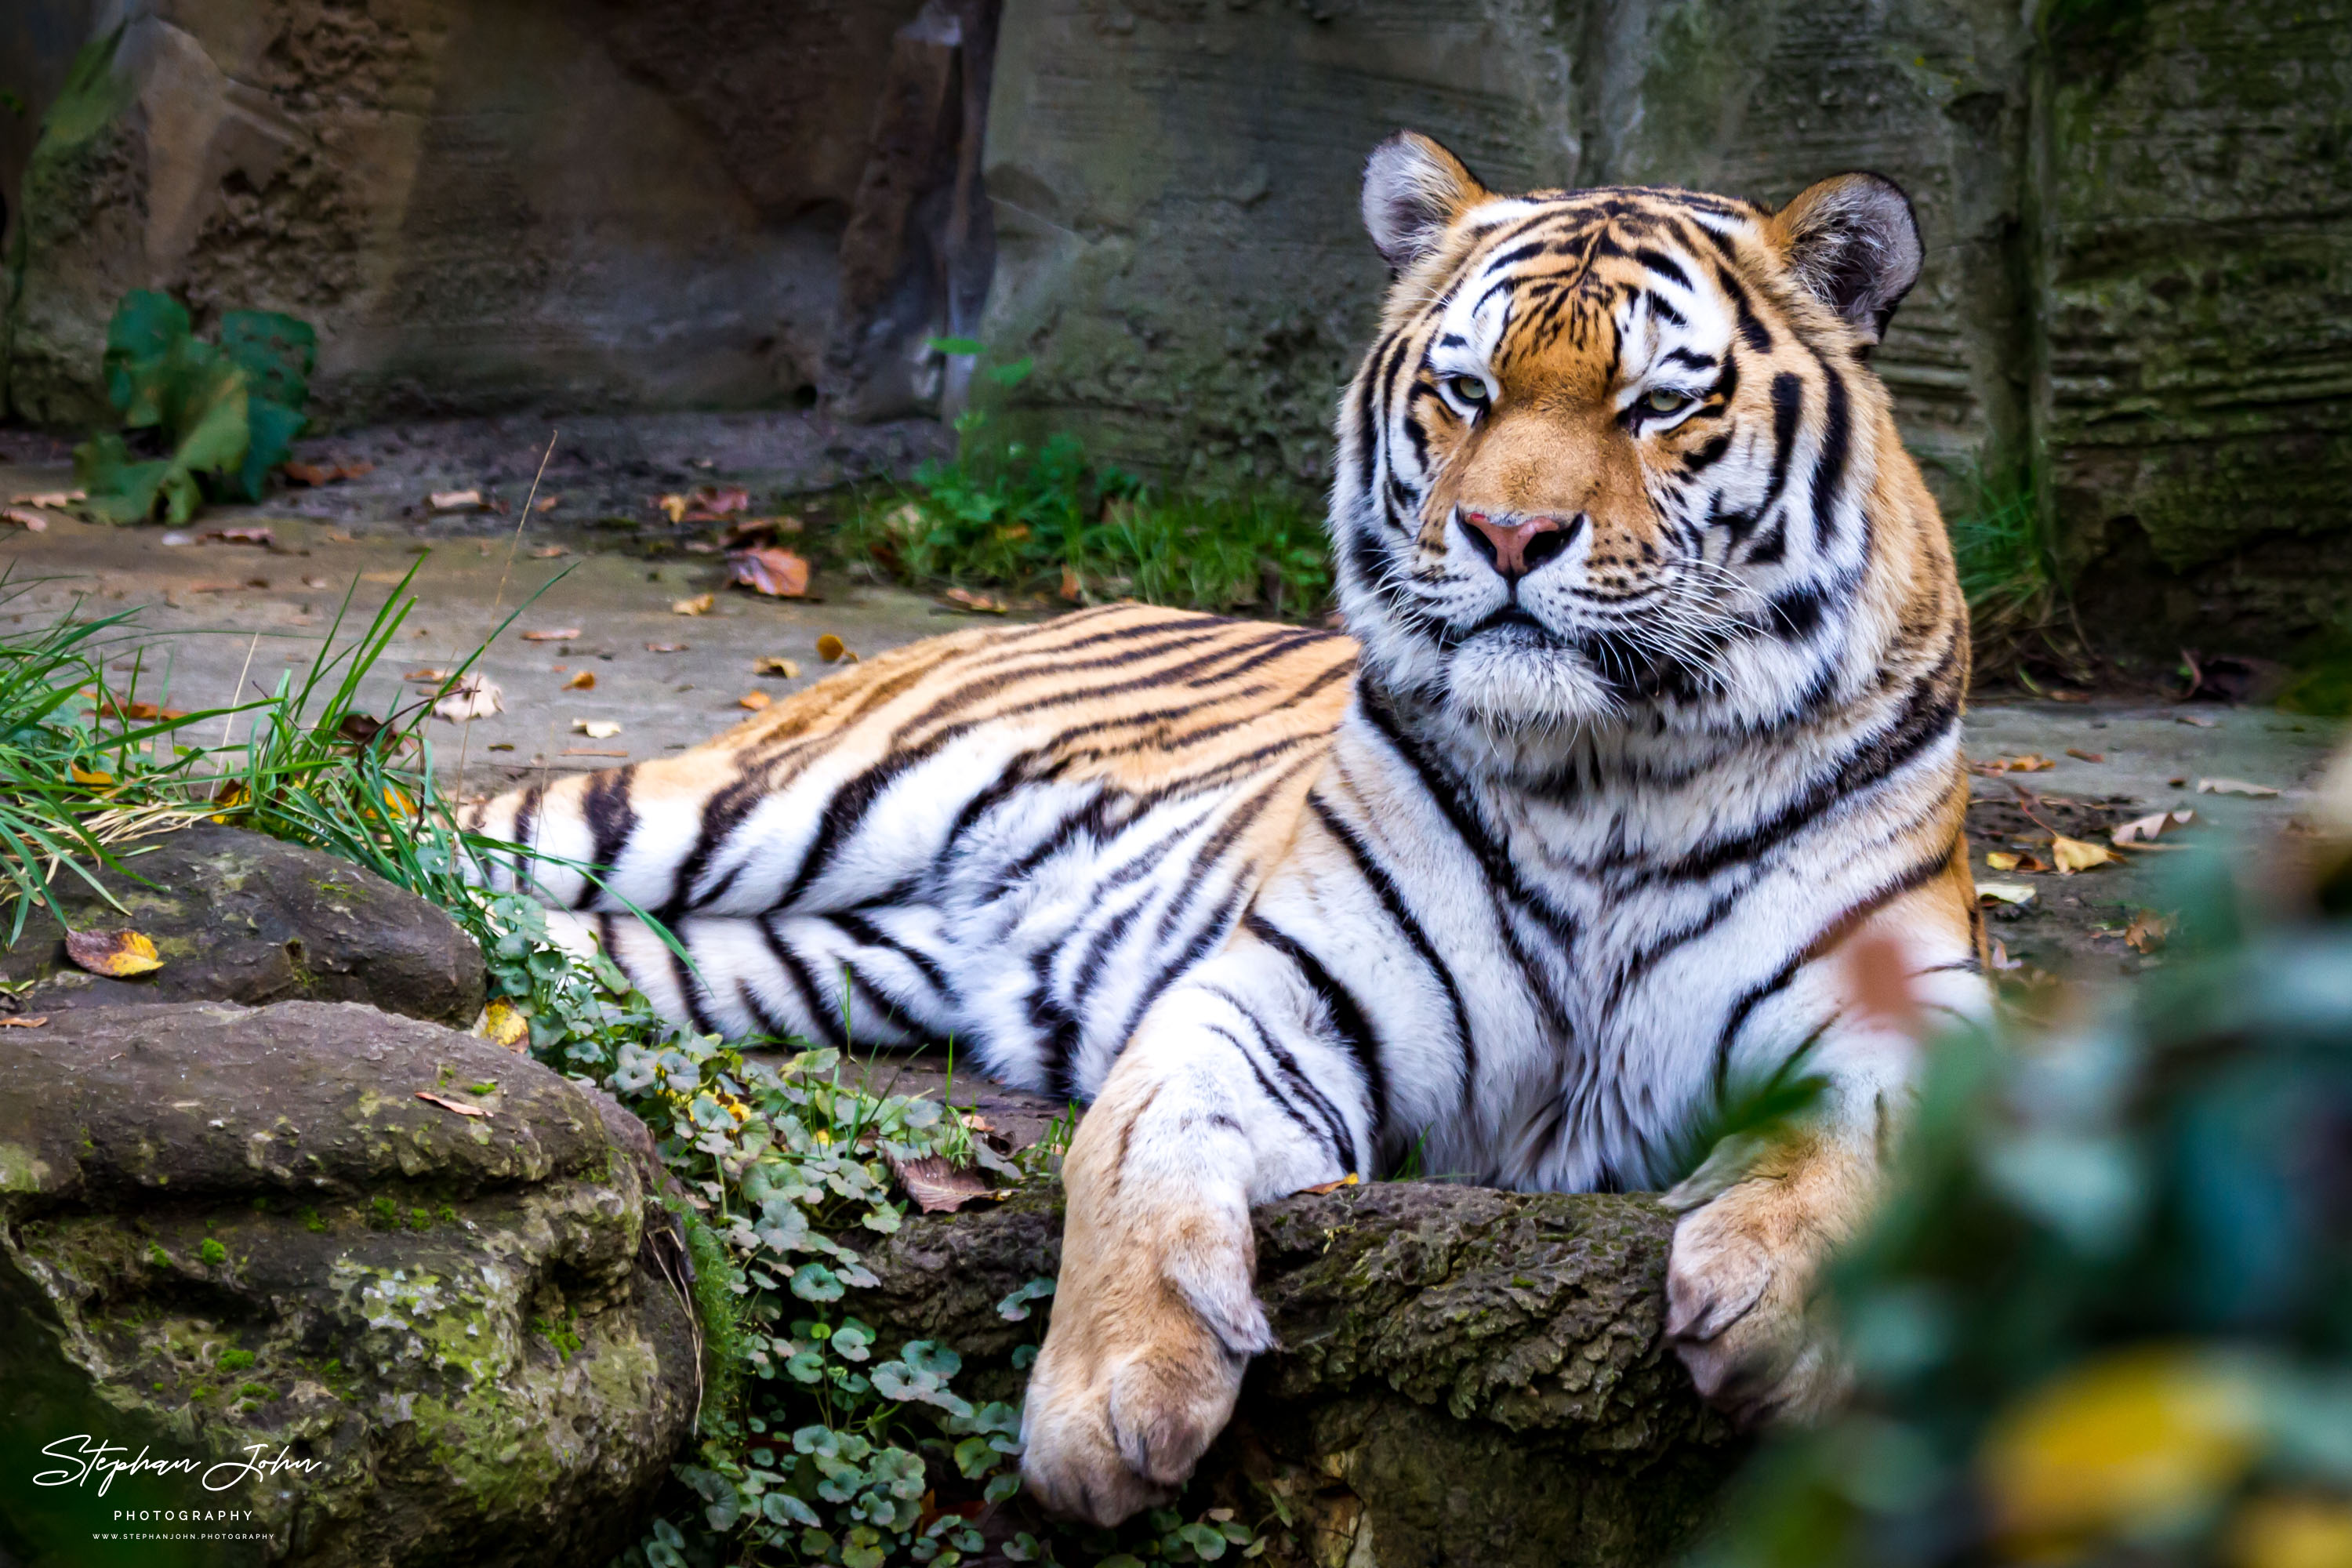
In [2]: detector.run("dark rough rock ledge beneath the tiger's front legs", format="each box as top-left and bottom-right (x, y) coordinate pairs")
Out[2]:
(847, 1182), (1745, 1568)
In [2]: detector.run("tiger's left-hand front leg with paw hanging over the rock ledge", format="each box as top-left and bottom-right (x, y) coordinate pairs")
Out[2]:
(1021, 973), (1371, 1526)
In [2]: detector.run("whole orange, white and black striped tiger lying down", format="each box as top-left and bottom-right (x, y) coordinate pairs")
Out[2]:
(468, 132), (1990, 1526)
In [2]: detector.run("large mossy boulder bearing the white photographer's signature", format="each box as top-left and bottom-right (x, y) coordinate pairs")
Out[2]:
(0, 1001), (701, 1568)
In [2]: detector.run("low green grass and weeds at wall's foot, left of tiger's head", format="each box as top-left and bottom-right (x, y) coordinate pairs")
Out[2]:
(837, 339), (1331, 619)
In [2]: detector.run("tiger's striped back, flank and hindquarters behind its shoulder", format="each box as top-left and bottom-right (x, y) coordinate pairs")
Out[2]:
(468, 604), (1355, 1093)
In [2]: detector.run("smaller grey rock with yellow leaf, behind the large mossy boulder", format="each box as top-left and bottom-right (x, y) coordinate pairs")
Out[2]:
(0, 822), (485, 1027)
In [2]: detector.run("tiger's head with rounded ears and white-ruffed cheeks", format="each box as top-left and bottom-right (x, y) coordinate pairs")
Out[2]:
(1331, 134), (1966, 746)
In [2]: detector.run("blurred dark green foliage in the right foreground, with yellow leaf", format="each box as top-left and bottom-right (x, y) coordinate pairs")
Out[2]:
(1686, 832), (2352, 1568)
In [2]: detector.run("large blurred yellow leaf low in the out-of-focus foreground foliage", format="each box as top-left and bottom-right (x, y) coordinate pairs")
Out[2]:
(1978, 1347), (2260, 1556)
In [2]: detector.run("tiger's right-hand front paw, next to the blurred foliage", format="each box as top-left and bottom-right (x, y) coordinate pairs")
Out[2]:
(1665, 1182), (1849, 1425)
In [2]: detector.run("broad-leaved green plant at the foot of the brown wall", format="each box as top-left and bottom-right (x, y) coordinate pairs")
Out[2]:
(73, 289), (318, 522)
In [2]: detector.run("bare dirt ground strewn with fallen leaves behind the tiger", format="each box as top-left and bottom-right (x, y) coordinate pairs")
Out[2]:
(0, 414), (2343, 1011)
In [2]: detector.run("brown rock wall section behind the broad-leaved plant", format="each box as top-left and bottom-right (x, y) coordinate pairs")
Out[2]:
(0, 0), (978, 426)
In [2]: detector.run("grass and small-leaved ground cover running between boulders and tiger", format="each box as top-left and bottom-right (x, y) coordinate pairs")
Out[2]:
(0, 569), (1265, 1568)
